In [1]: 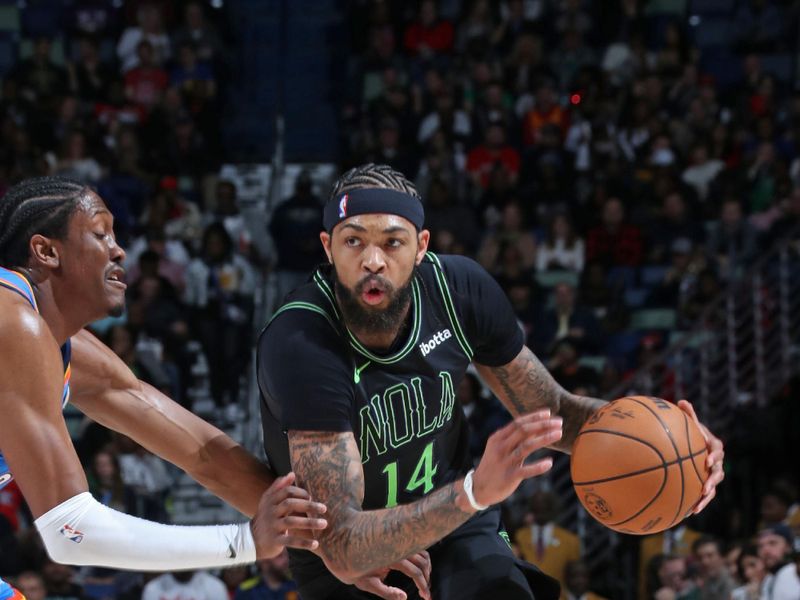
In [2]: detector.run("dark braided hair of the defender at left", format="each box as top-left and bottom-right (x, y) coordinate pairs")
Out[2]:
(0, 177), (89, 268)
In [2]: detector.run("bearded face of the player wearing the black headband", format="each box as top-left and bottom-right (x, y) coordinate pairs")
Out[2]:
(320, 214), (430, 312)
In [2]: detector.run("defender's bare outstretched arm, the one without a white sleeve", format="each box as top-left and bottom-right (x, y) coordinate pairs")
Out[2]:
(70, 331), (275, 516)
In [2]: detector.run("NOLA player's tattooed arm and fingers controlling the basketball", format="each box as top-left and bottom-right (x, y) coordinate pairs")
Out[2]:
(475, 346), (725, 512)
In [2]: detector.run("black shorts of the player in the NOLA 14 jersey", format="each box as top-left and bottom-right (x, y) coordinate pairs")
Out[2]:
(290, 507), (560, 600)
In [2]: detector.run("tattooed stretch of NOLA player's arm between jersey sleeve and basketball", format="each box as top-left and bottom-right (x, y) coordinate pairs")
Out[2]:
(475, 346), (606, 453)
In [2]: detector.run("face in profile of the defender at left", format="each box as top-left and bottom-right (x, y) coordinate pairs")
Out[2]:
(59, 192), (126, 321)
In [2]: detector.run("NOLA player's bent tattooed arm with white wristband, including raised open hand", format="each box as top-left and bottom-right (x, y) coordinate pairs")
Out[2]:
(289, 411), (561, 582)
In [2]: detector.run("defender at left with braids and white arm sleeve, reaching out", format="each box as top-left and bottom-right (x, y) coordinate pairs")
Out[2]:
(0, 178), (428, 600)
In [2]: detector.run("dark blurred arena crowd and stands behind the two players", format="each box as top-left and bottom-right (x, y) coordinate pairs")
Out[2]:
(0, 0), (800, 600)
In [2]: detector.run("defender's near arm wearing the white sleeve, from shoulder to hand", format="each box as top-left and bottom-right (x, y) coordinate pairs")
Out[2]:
(0, 300), (324, 571)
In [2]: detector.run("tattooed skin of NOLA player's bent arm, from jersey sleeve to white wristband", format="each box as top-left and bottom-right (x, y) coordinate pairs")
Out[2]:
(289, 431), (473, 582)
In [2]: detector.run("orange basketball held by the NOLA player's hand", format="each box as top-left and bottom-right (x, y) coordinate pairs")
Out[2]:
(571, 396), (708, 535)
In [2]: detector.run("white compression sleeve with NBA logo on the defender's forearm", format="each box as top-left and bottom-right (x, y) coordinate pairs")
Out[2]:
(35, 492), (256, 571)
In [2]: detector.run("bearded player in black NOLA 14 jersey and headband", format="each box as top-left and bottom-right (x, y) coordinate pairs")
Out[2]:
(258, 164), (723, 600)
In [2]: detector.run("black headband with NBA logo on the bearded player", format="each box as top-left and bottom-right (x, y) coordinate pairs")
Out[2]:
(322, 188), (425, 233)
